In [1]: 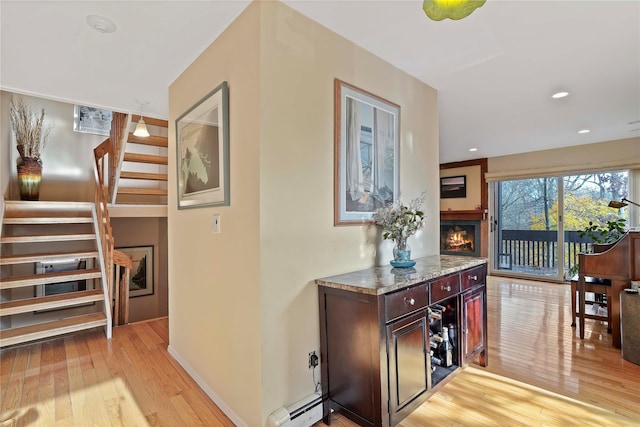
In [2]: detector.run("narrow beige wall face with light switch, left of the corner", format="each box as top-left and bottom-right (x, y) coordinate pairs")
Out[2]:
(168, 4), (264, 426)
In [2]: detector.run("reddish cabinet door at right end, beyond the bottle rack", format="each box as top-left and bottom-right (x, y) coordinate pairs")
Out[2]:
(462, 286), (486, 366)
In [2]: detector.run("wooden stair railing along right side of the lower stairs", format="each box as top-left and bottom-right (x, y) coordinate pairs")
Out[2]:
(93, 138), (133, 328)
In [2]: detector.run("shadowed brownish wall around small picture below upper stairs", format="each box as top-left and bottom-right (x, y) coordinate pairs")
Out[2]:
(111, 218), (168, 322)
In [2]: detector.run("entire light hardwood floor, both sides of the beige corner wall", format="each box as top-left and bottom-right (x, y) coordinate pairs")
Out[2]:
(0, 278), (640, 427)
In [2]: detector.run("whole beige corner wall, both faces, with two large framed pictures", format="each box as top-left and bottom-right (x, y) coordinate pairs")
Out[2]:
(169, 2), (439, 426)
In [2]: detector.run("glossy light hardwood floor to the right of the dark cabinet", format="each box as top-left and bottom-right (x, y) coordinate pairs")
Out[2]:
(316, 277), (640, 427)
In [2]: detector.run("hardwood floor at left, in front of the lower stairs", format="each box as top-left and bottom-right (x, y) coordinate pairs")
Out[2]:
(0, 318), (233, 427)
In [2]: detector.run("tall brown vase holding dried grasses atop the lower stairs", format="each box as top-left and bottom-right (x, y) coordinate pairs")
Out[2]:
(9, 98), (50, 200)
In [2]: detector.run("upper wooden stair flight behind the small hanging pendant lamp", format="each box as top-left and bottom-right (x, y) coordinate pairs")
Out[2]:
(111, 116), (168, 205)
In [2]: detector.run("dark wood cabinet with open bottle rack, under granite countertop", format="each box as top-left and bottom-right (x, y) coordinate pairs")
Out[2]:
(318, 264), (487, 427)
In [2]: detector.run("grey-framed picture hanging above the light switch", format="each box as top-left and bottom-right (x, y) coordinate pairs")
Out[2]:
(176, 82), (229, 209)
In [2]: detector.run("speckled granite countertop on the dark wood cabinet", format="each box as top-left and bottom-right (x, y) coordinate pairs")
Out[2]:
(316, 255), (487, 295)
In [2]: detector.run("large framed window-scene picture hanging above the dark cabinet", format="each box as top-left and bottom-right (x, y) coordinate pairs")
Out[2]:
(334, 79), (400, 225)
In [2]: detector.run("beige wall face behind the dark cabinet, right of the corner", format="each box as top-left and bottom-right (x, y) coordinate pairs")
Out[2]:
(260, 3), (439, 414)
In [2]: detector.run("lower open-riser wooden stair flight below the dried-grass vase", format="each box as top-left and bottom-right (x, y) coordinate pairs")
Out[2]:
(0, 201), (111, 347)
